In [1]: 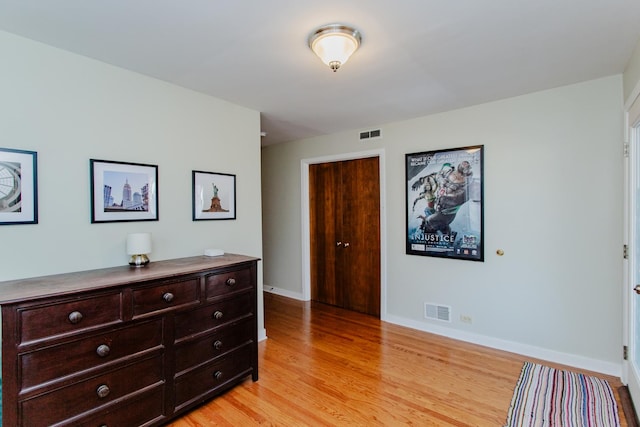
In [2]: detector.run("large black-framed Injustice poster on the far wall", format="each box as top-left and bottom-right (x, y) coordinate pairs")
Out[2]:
(405, 145), (484, 261)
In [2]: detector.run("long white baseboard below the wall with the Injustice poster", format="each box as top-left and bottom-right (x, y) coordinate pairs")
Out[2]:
(385, 315), (622, 378)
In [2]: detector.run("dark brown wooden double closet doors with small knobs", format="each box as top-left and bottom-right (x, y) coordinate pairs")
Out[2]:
(309, 157), (380, 317)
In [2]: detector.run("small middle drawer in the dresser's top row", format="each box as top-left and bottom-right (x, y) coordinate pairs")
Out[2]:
(133, 277), (200, 317)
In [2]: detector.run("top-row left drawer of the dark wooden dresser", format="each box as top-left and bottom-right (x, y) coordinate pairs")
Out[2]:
(18, 292), (123, 344)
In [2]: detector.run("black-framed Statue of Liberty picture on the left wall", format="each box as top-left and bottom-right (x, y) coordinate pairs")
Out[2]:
(191, 171), (236, 221)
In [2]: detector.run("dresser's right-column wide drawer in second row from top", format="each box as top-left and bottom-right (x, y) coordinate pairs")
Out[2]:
(175, 293), (253, 342)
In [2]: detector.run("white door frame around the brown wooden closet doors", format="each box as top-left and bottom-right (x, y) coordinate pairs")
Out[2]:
(300, 149), (387, 320)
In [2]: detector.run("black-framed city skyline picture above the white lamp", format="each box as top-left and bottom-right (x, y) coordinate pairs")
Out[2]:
(89, 159), (158, 223)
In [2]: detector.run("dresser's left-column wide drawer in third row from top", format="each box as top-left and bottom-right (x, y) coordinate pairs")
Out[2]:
(20, 356), (163, 427)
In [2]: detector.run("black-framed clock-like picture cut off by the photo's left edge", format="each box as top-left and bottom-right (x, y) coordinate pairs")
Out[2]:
(0, 148), (38, 225)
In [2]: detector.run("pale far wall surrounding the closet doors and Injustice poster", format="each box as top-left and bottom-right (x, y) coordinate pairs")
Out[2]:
(262, 76), (623, 374)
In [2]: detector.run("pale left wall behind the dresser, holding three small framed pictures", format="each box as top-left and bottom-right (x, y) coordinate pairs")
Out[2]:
(0, 32), (263, 336)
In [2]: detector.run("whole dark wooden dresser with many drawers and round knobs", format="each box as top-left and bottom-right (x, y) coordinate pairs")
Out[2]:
(0, 254), (258, 427)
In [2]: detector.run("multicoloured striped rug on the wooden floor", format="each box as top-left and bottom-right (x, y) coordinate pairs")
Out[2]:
(505, 362), (620, 427)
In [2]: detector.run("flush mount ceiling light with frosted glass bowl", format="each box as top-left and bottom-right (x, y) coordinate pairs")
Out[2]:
(309, 24), (362, 73)
